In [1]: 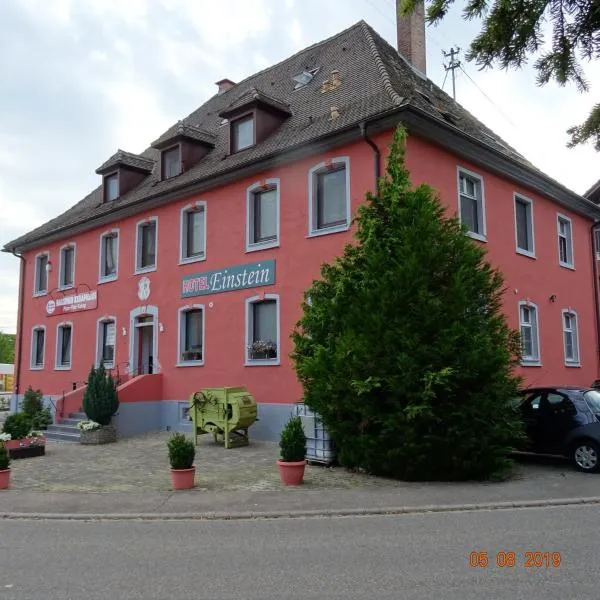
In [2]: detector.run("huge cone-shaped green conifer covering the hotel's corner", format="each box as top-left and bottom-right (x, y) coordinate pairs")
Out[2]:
(292, 128), (521, 480)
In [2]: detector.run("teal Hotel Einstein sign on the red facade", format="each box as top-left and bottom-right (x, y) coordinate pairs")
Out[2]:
(181, 260), (275, 298)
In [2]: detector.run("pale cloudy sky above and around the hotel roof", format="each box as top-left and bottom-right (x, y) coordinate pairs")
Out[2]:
(0, 0), (600, 333)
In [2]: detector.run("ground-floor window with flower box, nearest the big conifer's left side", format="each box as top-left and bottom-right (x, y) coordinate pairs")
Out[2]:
(245, 294), (281, 366)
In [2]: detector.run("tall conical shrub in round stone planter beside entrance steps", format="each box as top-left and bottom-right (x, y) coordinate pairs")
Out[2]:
(79, 365), (119, 444)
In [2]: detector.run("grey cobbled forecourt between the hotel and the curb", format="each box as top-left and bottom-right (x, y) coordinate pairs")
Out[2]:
(3, 432), (600, 501)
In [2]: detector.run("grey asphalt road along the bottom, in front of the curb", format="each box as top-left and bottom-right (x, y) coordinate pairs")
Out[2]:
(0, 506), (600, 600)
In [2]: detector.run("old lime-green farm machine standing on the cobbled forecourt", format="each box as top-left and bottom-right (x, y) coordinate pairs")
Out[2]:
(189, 387), (256, 448)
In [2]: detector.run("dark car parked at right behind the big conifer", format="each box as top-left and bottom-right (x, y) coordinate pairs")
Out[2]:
(520, 387), (600, 473)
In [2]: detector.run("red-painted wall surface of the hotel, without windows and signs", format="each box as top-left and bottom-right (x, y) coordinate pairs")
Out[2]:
(15, 128), (598, 403)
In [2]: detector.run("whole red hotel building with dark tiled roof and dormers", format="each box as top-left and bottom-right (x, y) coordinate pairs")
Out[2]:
(4, 21), (600, 438)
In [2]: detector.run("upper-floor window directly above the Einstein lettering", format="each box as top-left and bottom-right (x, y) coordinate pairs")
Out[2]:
(246, 178), (280, 252)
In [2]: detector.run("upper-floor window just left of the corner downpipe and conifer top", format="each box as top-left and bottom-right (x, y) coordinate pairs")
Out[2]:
(308, 156), (351, 236)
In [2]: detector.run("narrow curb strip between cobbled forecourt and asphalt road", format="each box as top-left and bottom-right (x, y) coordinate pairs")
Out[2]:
(0, 496), (600, 521)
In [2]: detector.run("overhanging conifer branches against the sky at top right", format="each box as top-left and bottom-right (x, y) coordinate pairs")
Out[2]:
(401, 0), (600, 151)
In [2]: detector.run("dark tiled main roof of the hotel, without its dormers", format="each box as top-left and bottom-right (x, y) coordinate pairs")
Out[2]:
(5, 21), (584, 249)
